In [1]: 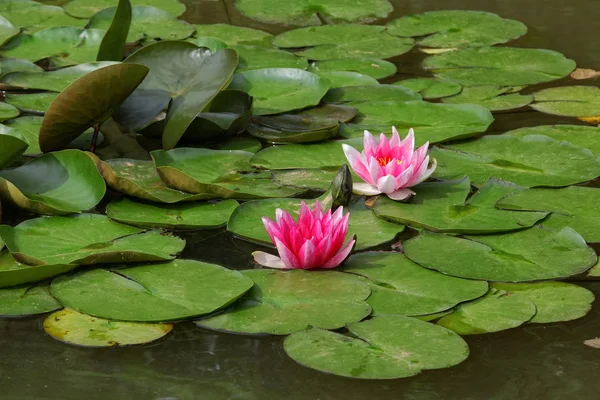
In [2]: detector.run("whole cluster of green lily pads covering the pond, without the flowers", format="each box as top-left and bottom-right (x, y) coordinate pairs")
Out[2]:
(0, 0), (600, 379)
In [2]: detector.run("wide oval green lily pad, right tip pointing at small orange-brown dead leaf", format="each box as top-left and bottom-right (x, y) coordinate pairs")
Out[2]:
(423, 47), (575, 86)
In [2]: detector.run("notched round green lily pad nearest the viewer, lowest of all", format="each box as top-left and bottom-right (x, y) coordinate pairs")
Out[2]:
(283, 315), (469, 379)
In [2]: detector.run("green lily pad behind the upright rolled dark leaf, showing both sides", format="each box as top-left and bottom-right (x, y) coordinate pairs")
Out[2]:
(87, 6), (196, 43)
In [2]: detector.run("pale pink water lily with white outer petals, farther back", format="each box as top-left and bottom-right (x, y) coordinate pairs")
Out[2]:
(342, 127), (437, 200)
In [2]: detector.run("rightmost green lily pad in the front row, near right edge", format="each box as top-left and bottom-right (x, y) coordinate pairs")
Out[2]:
(492, 282), (594, 324)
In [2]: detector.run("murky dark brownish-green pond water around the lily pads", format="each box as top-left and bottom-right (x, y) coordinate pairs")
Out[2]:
(0, 0), (600, 400)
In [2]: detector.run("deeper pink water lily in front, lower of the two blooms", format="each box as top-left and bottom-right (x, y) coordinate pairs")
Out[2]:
(252, 200), (356, 269)
